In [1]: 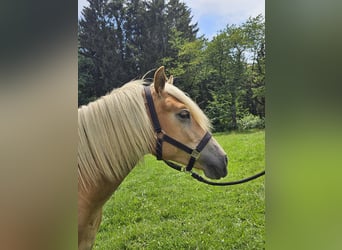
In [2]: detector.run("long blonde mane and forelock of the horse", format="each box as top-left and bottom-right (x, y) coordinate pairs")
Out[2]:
(78, 80), (211, 189)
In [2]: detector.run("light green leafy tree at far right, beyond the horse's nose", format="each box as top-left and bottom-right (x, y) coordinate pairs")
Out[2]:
(205, 16), (265, 130)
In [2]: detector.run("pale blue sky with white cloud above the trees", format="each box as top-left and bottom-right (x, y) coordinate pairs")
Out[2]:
(78, 0), (265, 39)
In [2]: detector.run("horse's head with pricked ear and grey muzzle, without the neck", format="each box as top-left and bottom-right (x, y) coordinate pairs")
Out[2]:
(145, 67), (228, 179)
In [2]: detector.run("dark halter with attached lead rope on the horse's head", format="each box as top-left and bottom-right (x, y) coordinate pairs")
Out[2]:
(144, 86), (265, 186)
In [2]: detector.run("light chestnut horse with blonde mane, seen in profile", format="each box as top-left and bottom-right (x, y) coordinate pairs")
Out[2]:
(78, 66), (228, 250)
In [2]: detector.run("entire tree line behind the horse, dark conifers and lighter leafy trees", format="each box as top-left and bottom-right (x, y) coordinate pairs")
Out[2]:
(79, 0), (266, 131)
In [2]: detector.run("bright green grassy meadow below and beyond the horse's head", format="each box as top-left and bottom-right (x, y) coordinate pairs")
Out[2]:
(94, 131), (265, 250)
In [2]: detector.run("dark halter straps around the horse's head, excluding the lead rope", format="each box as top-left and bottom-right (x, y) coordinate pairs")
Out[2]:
(144, 86), (211, 171)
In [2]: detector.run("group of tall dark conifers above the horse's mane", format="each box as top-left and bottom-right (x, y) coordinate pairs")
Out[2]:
(78, 0), (198, 105)
